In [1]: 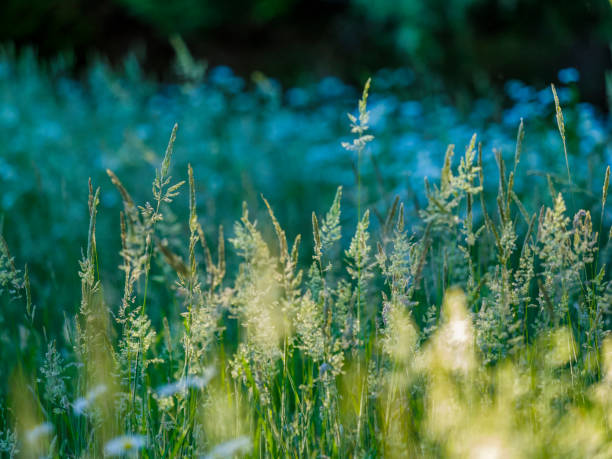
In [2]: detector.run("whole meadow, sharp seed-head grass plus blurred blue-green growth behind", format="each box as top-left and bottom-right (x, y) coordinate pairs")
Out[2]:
(0, 56), (612, 458)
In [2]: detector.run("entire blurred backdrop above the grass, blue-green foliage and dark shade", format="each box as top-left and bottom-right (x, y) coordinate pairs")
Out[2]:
(0, 0), (612, 336)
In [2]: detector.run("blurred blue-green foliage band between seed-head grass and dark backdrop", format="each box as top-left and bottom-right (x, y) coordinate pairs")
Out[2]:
(0, 46), (612, 330)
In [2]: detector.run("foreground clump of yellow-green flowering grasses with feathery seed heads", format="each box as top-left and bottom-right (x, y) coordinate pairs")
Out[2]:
(0, 77), (612, 458)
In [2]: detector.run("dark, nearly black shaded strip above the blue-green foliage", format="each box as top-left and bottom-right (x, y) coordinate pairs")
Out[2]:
(0, 0), (612, 108)
